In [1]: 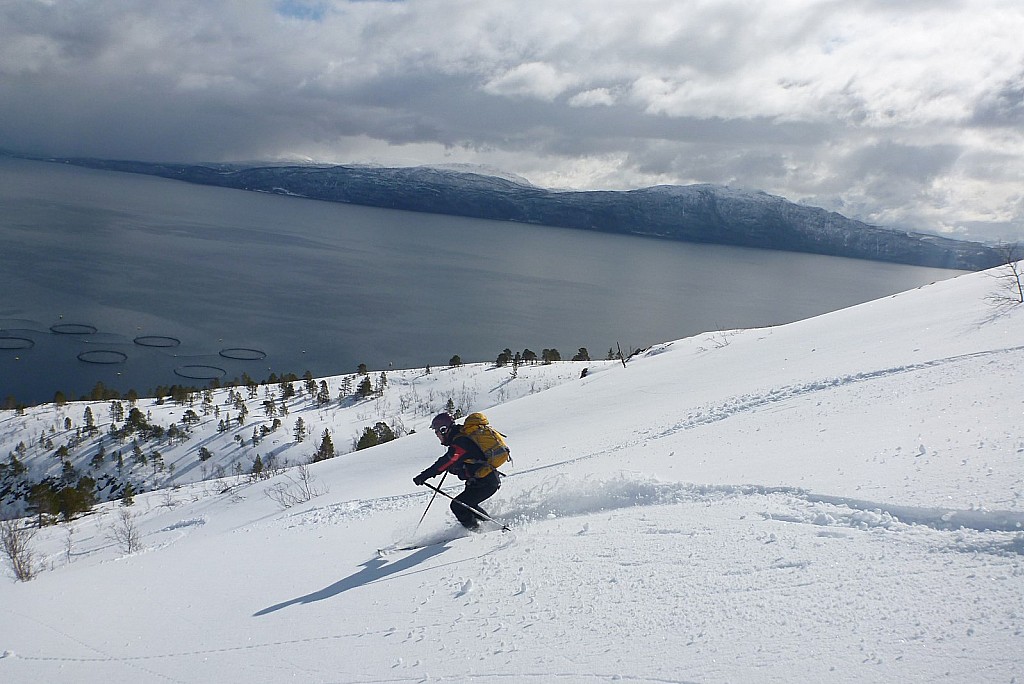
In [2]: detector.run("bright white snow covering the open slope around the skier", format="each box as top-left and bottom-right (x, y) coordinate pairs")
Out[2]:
(0, 264), (1024, 683)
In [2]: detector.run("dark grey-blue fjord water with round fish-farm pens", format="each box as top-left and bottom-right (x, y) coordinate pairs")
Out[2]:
(0, 158), (961, 403)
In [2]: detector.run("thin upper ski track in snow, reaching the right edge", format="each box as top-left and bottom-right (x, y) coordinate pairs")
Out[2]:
(649, 345), (1024, 439)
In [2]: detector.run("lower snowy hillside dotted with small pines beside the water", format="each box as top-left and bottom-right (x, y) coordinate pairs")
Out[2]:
(0, 352), (608, 511)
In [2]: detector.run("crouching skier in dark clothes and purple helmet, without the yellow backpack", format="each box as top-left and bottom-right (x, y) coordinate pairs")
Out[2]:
(413, 413), (502, 529)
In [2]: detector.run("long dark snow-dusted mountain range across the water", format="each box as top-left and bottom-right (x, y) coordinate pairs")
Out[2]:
(36, 159), (999, 270)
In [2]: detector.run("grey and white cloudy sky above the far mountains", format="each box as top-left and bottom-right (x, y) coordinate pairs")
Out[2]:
(0, 0), (1024, 240)
